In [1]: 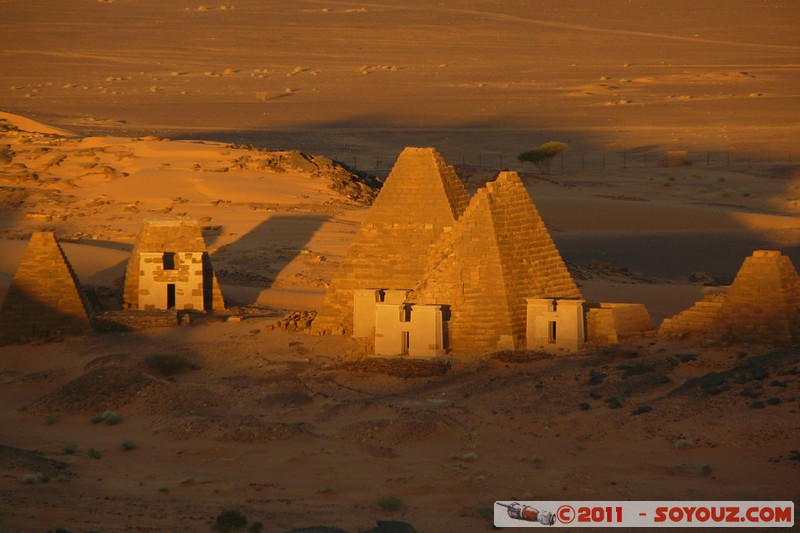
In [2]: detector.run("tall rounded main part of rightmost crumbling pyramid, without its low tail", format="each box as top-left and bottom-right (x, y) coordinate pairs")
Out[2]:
(714, 250), (800, 344)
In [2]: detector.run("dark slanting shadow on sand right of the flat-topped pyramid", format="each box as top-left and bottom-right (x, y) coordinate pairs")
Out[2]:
(211, 213), (330, 305)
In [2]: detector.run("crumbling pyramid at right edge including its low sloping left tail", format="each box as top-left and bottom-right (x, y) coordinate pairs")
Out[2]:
(659, 250), (800, 345)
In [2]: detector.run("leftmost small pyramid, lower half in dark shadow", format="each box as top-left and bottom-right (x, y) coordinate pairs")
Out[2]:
(0, 231), (93, 342)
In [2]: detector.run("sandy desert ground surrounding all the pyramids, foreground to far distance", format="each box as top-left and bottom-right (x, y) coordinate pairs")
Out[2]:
(0, 0), (800, 532)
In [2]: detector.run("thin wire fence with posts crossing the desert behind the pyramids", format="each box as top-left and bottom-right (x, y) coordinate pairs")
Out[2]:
(334, 151), (799, 176)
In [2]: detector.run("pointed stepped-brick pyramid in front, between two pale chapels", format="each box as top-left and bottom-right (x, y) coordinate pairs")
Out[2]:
(410, 172), (581, 351)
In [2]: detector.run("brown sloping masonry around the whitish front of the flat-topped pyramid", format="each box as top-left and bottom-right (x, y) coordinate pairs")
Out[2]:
(123, 220), (225, 311)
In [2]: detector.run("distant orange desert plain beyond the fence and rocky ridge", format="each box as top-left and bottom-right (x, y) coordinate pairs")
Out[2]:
(0, 0), (800, 164)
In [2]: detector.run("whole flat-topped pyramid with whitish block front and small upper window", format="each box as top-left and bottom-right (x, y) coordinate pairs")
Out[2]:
(123, 219), (225, 311)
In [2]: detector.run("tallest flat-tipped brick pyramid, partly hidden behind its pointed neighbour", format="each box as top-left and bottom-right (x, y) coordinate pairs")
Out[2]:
(313, 148), (469, 333)
